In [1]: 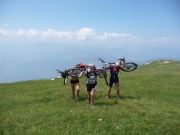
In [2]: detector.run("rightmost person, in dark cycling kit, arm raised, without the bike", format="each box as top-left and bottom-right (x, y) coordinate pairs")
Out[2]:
(106, 59), (125, 99)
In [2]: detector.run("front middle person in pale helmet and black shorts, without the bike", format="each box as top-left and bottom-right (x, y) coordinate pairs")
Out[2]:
(79, 63), (103, 106)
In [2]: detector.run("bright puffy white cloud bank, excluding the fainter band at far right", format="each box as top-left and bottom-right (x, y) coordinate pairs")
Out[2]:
(0, 28), (139, 41)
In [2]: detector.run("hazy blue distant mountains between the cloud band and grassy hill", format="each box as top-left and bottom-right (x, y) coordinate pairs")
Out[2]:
(0, 44), (180, 83)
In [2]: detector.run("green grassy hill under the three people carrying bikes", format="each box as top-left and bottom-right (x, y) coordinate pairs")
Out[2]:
(0, 61), (180, 135)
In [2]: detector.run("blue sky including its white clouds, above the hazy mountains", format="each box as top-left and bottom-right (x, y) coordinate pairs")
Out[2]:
(0, 0), (180, 42)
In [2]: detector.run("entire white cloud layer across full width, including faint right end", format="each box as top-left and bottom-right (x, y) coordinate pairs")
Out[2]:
(0, 27), (180, 44)
